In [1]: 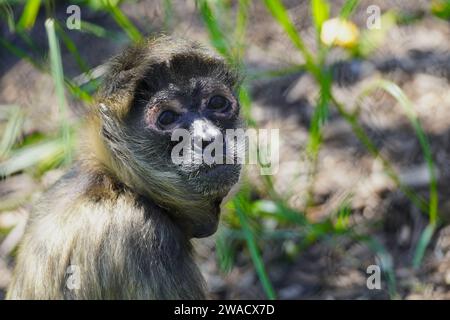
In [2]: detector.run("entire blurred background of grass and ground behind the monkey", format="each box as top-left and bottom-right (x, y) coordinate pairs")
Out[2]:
(0, 0), (450, 299)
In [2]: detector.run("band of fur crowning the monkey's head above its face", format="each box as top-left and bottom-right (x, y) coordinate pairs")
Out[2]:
(98, 36), (241, 118)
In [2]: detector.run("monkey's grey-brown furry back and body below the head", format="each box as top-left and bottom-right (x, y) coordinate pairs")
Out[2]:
(7, 168), (204, 299)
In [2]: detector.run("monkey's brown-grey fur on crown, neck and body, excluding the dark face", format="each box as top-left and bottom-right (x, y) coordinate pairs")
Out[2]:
(7, 37), (243, 299)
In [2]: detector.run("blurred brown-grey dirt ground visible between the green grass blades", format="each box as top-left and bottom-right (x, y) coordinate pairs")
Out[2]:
(0, 1), (450, 299)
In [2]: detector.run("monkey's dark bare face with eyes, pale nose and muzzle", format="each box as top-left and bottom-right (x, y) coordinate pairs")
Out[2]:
(128, 77), (242, 195)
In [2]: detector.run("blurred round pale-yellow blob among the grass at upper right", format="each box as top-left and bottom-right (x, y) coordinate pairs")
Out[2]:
(320, 18), (359, 48)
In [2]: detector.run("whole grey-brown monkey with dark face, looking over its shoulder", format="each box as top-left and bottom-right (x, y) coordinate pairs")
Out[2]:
(7, 36), (245, 299)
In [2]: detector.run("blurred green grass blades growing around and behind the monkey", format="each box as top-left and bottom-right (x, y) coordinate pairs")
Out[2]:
(0, 0), (442, 299)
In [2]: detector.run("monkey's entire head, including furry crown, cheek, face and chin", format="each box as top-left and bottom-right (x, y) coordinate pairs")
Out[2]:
(86, 37), (243, 237)
